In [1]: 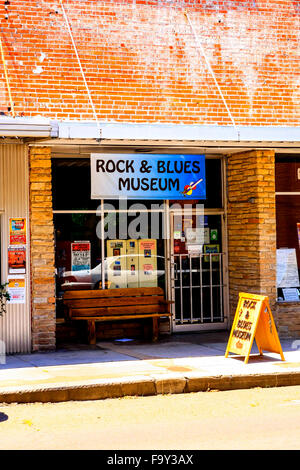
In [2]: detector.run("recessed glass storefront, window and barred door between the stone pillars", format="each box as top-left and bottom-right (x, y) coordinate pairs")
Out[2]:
(53, 158), (227, 338)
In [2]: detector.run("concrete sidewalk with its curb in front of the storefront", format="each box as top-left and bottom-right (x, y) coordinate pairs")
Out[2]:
(0, 331), (300, 403)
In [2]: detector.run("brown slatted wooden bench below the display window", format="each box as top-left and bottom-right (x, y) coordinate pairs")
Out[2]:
(63, 287), (172, 344)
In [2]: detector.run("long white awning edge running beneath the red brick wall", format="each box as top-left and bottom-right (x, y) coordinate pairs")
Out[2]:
(0, 116), (300, 146)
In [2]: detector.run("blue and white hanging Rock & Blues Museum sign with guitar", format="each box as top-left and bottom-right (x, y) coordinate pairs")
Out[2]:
(91, 153), (206, 200)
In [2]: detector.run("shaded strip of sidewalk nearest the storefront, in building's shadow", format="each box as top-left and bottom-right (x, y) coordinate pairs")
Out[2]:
(0, 330), (295, 370)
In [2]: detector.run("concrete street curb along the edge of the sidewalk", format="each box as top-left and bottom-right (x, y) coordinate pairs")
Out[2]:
(0, 372), (300, 403)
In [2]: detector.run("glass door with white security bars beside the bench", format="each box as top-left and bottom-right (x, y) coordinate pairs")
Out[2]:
(170, 211), (226, 331)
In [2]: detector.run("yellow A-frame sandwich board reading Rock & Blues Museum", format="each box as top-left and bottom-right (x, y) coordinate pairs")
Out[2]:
(225, 292), (285, 364)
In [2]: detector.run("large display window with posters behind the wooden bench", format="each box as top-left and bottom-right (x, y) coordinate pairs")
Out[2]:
(54, 211), (166, 314)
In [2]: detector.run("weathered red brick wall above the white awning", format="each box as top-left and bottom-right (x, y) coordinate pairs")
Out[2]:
(0, 0), (300, 126)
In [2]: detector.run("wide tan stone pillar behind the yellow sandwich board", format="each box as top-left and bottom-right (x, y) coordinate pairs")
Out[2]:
(227, 150), (276, 320)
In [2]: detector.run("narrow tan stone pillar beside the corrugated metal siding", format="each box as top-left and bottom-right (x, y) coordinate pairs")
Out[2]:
(29, 147), (56, 351)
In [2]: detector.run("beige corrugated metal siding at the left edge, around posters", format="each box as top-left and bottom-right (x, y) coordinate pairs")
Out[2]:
(0, 144), (31, 353)
